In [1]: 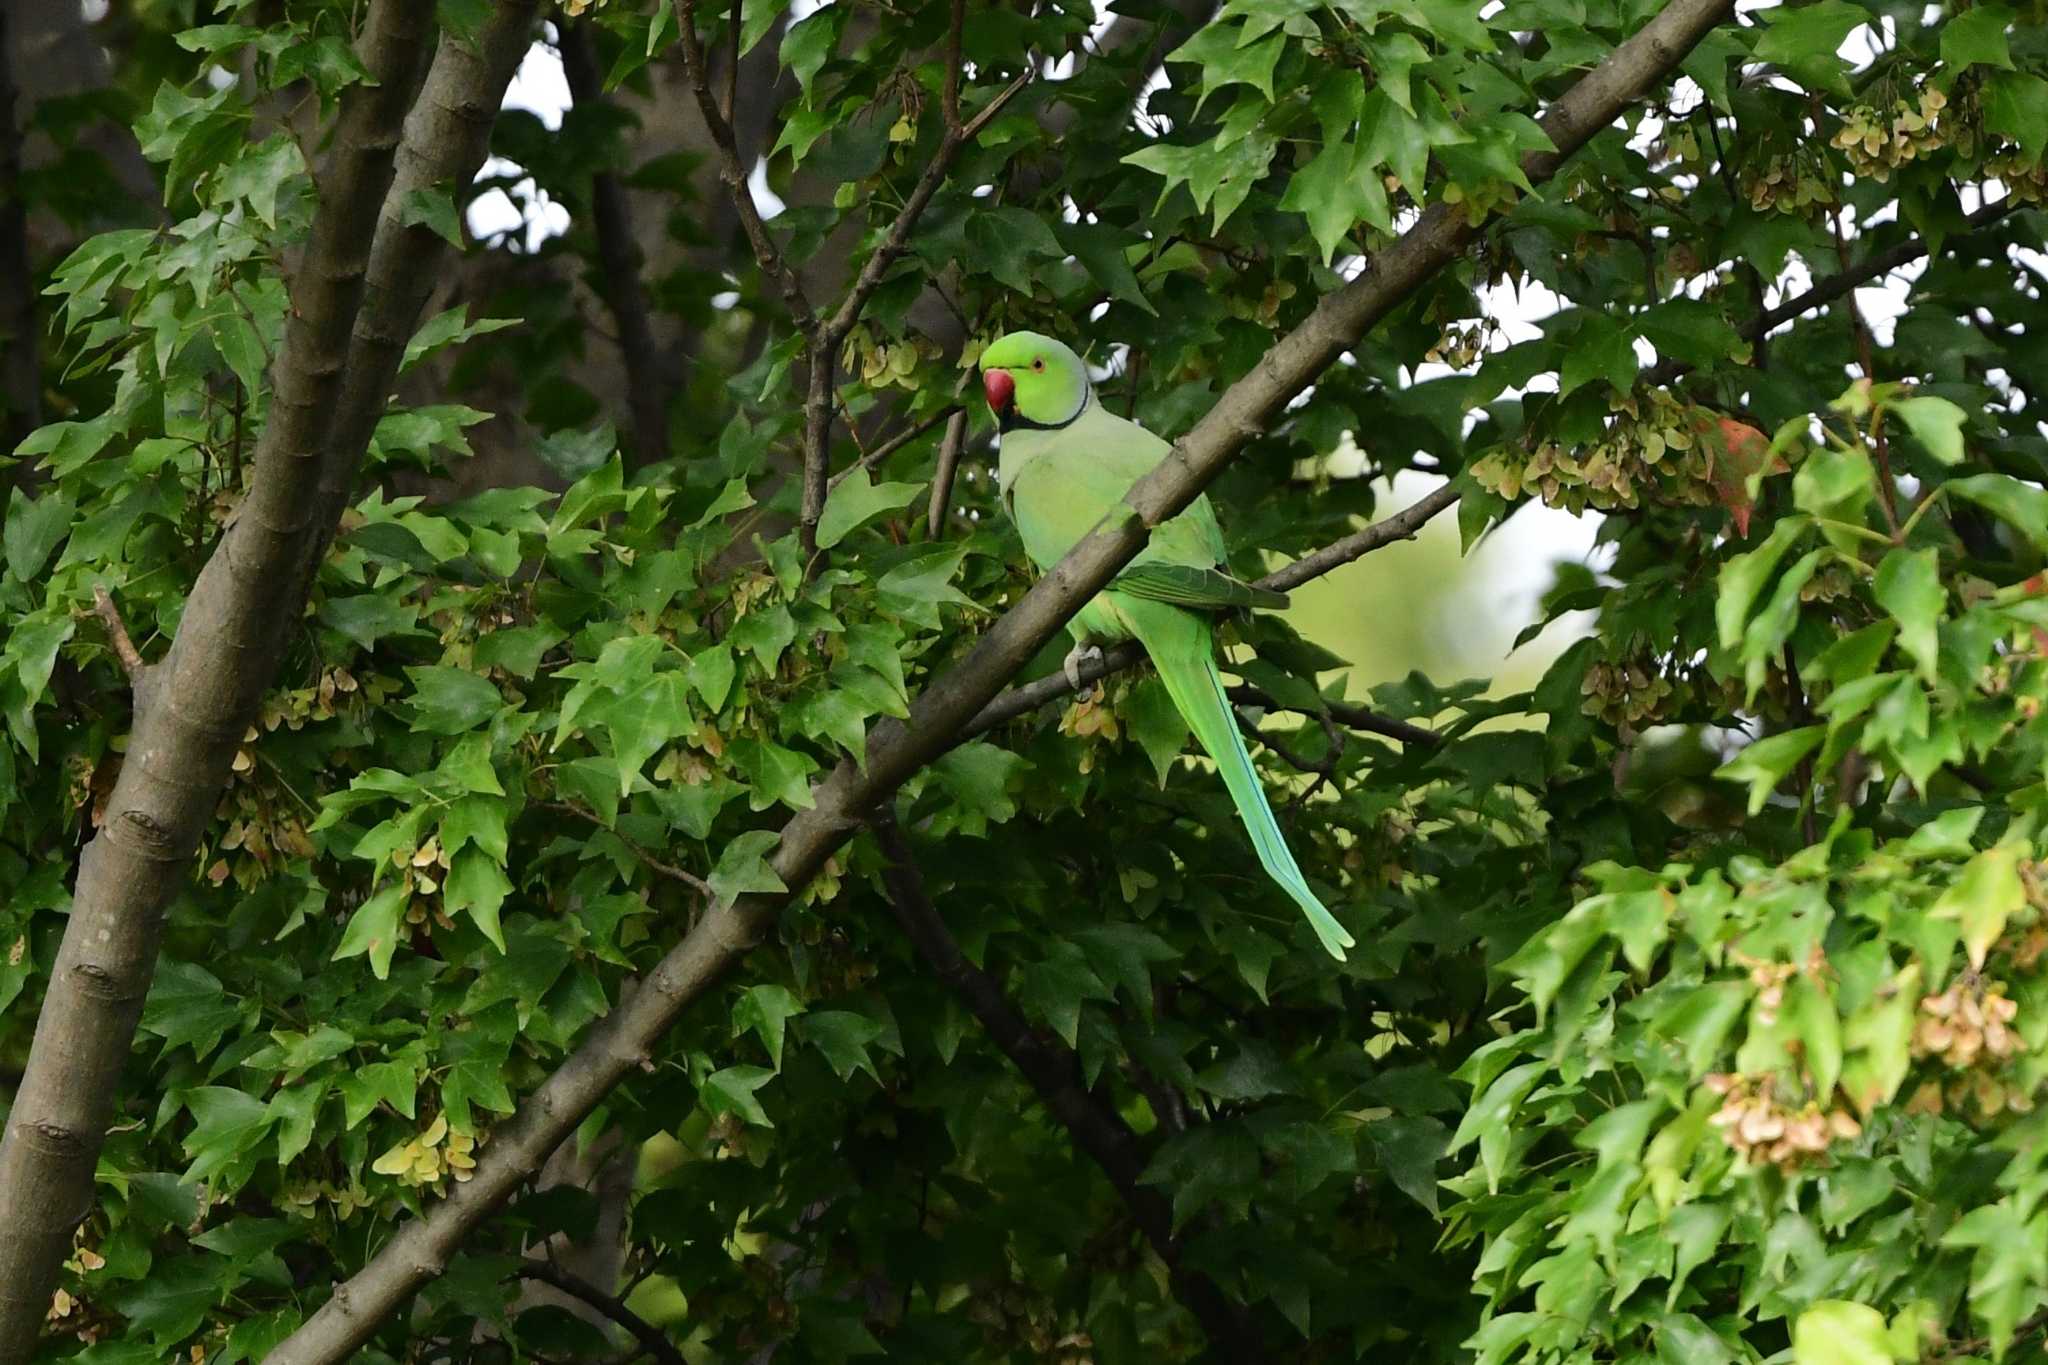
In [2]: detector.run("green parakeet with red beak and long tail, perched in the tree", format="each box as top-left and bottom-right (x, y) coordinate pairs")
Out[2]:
(981, 332), (1354, 962)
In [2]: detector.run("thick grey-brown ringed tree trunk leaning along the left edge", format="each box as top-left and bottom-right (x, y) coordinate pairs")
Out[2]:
(0, 0), (535, 1365)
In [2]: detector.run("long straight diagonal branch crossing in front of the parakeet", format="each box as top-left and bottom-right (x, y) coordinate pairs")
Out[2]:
(251, 0), (1733, 1365)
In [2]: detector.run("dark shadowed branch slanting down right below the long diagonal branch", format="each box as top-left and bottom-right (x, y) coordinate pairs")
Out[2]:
(868, 802), (1264, 1361)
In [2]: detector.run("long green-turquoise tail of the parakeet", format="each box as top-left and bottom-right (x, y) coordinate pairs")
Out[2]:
(1116, 593), (1356, 962)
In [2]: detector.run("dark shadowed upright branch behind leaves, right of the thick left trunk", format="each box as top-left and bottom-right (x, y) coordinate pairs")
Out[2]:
(559, 20), (671, 467)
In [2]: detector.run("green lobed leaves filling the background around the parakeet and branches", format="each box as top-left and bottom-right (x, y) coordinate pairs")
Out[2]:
(0, 0), (2048, 1365)
